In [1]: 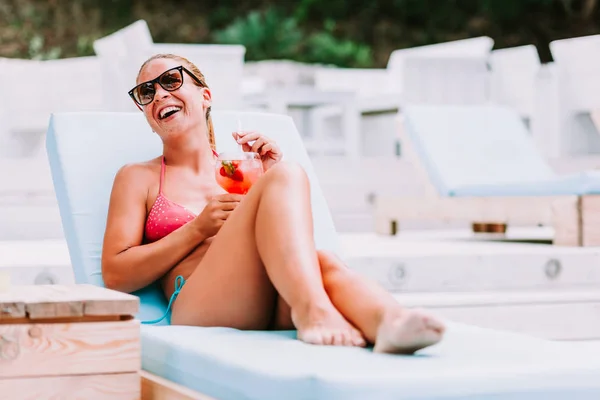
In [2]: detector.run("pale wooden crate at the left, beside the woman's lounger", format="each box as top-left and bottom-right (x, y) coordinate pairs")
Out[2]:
(0, 285), (141, 400)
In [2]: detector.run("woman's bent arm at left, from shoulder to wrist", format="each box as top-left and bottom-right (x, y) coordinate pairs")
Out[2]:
(102, 165), (207, 293)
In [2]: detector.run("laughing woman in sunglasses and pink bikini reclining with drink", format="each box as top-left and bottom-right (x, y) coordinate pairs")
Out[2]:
(102, 55), (444, 353)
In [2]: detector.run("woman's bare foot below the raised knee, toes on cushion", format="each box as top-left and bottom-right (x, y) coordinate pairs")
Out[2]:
(292, 304), (366, 347)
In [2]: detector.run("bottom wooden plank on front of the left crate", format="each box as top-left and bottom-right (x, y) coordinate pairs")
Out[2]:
(0, 373), (141, 400)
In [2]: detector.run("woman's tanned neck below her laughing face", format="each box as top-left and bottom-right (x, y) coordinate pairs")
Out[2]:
(163, 126), (214, 174)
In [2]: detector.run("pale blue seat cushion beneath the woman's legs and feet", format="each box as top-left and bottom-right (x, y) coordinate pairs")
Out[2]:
(142, 324), (600, 400)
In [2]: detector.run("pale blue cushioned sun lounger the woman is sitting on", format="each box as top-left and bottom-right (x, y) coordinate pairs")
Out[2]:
(47, 111), (600, 400)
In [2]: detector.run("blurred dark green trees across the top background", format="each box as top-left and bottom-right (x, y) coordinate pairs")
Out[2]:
(0, 0), (600, 67)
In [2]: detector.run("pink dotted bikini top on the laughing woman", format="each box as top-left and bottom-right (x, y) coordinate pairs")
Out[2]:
(144, 157), (196, 243)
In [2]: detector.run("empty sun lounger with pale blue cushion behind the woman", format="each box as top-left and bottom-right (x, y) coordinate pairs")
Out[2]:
(376, 105), (600, 246)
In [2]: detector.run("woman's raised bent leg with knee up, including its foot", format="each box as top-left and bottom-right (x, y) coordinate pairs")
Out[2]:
(172, 163), (365, 345)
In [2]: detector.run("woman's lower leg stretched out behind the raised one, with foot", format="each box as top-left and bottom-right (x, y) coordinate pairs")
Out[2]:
(274, 250), (445, 354)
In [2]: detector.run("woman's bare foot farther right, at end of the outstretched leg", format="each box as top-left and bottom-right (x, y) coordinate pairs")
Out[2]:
(373, 310), (445, 354)
